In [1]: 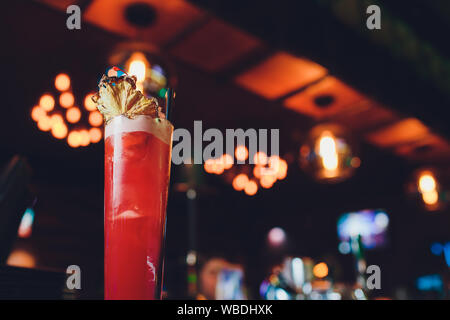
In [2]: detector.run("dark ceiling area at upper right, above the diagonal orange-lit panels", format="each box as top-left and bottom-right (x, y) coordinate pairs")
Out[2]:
(192, 0), (450, 137)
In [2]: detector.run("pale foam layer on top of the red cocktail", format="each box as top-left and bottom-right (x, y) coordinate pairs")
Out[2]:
(105, 115), (173, 144)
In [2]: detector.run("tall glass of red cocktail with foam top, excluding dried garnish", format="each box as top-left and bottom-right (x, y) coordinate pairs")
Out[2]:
(105, 115), (173, 299)
